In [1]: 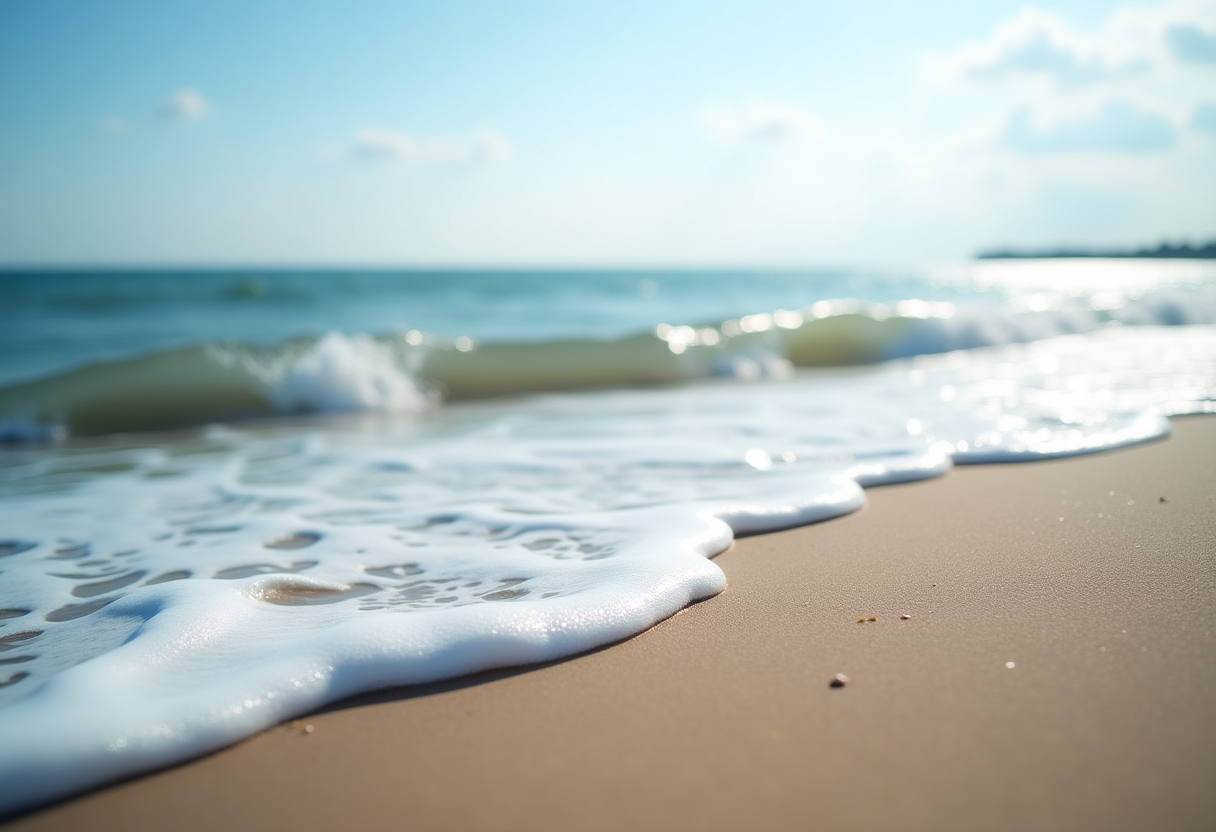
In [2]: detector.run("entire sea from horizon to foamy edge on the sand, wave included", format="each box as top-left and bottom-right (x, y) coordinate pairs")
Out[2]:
(0, 260), (1216, 813)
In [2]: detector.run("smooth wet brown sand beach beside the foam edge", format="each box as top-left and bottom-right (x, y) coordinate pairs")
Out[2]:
(10, 417), (1216, 832)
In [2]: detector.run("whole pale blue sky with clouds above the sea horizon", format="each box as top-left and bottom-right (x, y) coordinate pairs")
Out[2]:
(0, 0), (1216, 268)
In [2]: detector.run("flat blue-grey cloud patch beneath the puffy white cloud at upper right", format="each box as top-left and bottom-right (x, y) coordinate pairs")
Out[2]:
(1002, 101), (1177, 153)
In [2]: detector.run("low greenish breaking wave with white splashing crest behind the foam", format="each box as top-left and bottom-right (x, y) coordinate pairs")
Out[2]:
(0, 292), (1216, 443)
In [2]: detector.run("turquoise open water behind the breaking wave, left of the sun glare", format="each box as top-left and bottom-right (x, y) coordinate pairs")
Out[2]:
(0, 270), (1000, 384)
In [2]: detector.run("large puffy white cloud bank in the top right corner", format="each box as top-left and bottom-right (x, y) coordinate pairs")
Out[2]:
(928, 0), (1216, 169)
